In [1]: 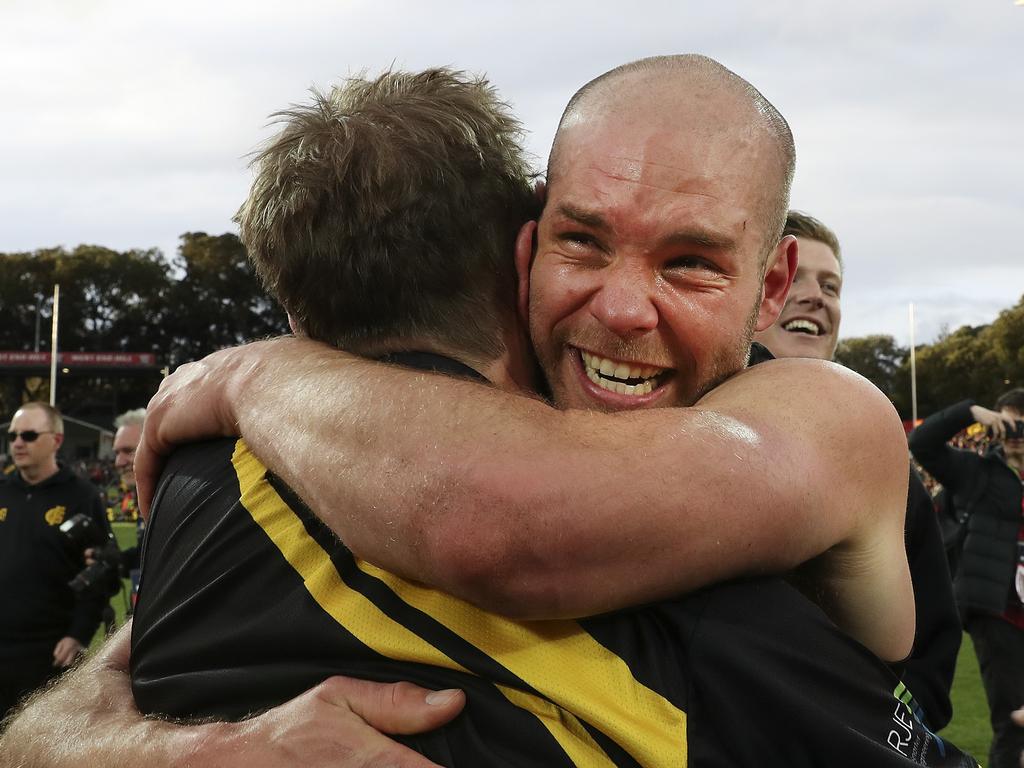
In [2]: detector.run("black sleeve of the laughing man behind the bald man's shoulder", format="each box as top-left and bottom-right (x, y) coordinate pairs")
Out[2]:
(901, 468), (963, 730)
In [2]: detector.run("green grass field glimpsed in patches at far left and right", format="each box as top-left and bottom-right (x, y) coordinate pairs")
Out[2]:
(92, 522), (992, 764)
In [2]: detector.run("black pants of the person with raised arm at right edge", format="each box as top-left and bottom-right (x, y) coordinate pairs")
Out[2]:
(967, 615), (1024, 768)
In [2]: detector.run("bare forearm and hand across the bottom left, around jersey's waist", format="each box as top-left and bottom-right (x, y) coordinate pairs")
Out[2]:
(0, 625), (465, 768)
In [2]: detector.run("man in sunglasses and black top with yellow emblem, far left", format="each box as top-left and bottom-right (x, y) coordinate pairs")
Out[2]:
(0, 402), (111, 718)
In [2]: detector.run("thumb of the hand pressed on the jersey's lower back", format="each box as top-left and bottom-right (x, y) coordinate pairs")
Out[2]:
(322, 677), (466, 734)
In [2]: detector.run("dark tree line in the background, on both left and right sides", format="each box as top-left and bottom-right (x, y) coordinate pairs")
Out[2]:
(0, 232), (1024, 419)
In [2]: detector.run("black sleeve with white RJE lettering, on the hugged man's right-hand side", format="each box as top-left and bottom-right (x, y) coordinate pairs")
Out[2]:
(687, 580), (977, 768)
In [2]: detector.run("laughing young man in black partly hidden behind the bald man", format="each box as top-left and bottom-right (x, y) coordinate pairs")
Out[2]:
(754, 211), (963, 730)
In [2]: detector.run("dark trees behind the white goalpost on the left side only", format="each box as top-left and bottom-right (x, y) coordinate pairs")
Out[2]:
(0, 232), (288, 422)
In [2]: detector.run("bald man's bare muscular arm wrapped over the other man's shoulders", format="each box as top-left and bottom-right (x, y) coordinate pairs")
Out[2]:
(140, 339), (913, 659)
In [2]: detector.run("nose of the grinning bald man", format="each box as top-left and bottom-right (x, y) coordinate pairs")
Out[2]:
(590, 264), (658, 338)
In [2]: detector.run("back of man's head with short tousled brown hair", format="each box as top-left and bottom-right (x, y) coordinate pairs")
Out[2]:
(237, 69), (537, 360)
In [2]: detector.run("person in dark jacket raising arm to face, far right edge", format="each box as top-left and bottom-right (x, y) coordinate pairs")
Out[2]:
(910, 388), (1024, 768)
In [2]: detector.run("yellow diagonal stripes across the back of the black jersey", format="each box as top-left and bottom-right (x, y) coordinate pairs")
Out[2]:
(231, 440), (686, 768)
